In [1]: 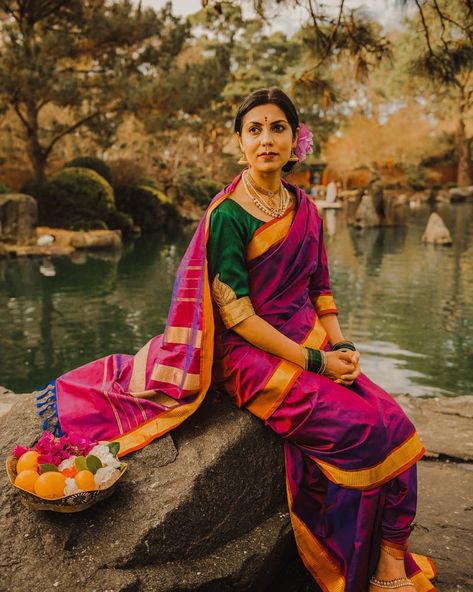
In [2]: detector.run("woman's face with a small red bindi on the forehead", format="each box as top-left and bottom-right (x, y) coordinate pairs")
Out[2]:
(238, 103), (297, 173)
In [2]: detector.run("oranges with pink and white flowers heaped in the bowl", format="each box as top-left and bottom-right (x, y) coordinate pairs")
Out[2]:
(12, 432), (122, 500)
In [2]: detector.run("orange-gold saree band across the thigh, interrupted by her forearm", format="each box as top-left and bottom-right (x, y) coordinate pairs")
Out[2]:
(246, 314), (327, 420)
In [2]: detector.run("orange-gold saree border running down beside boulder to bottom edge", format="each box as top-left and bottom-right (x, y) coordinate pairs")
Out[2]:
(286, 475), (346, 592)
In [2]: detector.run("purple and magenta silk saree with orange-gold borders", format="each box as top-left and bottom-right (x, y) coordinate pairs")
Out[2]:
(38, 176), (434, 592)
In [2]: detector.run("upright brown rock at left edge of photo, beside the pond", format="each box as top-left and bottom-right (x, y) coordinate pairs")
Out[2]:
(0, 193), (38, 245)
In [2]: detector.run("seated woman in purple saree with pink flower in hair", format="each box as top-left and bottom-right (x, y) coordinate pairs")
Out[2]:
(38, 88), (434, 592)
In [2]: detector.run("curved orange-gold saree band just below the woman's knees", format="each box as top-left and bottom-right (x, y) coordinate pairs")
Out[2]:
(314, 432), (425, 489)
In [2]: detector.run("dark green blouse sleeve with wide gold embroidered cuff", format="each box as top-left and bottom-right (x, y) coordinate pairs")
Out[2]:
(207, 208), (255, 329)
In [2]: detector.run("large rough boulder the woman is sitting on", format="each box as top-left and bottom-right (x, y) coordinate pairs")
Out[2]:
(0, 393), (298, 592)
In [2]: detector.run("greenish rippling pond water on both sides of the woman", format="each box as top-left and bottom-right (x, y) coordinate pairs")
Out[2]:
(0, 204), (473, 396)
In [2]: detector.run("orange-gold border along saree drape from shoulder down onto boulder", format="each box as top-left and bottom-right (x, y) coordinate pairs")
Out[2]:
(114, 193), (228, 457)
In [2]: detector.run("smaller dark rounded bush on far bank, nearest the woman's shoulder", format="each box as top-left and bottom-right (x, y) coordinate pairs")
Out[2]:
(115, 185), (179, 231)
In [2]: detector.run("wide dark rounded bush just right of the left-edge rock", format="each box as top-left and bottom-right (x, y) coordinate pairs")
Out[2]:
(32, 167), (115, 228)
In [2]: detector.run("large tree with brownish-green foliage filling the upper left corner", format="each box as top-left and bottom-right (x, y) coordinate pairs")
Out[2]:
(0, 0), (187, 178)
